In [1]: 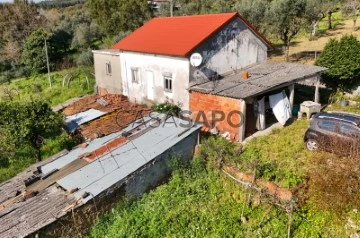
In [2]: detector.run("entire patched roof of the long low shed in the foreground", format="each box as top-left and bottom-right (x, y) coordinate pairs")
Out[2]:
(0, 113), (201, 237)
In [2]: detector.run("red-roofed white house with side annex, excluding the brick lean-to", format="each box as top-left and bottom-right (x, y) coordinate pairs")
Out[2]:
(94, 13), (272, 110)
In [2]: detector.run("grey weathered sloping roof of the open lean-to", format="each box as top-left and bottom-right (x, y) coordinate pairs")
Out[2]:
(190, 61), (326, 99)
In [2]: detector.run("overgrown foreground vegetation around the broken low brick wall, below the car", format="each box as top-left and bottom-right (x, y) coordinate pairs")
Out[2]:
(89, 115), (360, 237)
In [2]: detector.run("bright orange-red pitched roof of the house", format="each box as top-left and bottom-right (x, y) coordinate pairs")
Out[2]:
(113, 13), (273, 57)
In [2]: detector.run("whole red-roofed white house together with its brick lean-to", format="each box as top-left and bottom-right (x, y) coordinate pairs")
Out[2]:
(94, 13), (326, 141)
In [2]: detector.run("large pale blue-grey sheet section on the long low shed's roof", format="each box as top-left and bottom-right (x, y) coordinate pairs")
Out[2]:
(57, 118), (201, 202)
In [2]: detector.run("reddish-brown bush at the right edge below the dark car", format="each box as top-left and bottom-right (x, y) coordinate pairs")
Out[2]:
(308, 154), (360, 215)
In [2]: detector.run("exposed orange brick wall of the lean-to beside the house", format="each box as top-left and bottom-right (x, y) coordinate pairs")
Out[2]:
(190, 92), (241, 141)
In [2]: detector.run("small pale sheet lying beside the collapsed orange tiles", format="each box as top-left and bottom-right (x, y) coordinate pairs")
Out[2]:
(65, 109), (107, 133)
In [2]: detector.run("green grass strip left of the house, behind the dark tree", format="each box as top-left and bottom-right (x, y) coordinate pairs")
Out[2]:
(0, 68), (95, 106)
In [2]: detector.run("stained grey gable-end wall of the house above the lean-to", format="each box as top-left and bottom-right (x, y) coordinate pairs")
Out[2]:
(190, 18), (267, 83)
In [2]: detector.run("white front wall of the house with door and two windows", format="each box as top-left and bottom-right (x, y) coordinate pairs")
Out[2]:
(121, 52), (190, 110)
